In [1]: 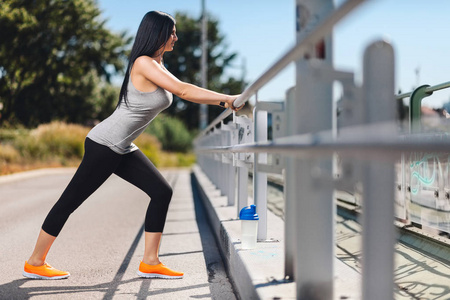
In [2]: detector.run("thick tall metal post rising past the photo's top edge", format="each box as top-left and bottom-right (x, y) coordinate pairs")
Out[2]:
(294, 0), (335, 300)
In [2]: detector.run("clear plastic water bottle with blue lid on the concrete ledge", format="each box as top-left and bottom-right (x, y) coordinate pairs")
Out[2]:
(239, 204), (259, 249)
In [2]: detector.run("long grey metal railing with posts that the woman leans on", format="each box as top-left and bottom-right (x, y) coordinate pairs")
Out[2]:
(194, 0), (450, 299)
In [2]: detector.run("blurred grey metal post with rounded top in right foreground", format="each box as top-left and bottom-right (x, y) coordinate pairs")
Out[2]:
(362, 41), (396, 300)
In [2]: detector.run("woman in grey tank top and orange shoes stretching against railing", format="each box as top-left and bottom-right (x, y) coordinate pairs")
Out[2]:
(23, 11), (240, 279)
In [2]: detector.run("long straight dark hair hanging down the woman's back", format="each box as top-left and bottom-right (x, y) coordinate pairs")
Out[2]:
(117, 11), (176, 106)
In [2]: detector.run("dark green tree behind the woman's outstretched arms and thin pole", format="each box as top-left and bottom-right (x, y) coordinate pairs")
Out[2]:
(164, 13), (243, 130)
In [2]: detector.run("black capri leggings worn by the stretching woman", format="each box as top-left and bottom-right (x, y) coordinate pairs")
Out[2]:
(42, 138), (172, 236)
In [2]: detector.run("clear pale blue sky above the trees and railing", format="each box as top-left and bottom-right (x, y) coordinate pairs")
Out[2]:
(98, 0), (450, 107)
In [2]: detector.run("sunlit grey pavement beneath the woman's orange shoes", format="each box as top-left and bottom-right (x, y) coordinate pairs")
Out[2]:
(0, 169), (236, 300)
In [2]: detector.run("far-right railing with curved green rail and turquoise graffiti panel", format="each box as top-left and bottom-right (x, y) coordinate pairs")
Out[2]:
(395, 82), (450, 234)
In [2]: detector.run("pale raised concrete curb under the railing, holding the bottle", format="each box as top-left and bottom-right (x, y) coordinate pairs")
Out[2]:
(193, 167), (295, 300)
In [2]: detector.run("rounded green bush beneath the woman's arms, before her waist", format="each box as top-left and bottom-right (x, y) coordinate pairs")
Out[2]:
(146, 114), (192, 153)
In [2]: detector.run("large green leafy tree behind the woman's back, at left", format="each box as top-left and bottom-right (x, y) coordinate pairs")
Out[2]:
(0, 0), (131, 126)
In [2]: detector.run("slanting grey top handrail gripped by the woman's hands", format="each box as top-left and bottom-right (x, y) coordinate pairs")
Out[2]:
(198, 0), (366, 136)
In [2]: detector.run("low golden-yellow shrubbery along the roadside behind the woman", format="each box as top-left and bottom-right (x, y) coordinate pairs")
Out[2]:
(0, 122), (195, 174)
